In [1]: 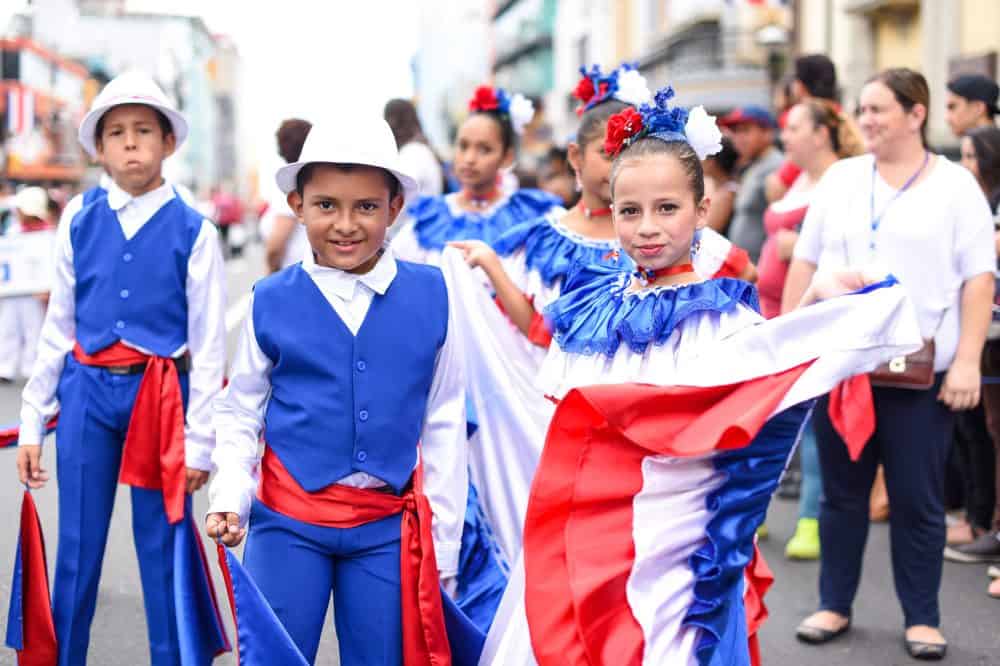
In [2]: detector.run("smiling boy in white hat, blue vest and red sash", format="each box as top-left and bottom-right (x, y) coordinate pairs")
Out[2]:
(206, 118), (468, 664)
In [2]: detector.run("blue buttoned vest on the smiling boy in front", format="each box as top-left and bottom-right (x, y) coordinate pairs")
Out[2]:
(253, 261), (448, 492)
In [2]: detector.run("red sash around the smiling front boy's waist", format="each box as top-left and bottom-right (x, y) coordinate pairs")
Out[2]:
(257, 448), (451, 666)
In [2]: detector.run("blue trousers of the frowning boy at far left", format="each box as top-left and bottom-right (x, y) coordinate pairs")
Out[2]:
(52, 355), (191, 666)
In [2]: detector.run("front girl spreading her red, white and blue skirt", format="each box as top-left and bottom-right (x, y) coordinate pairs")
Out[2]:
(458, 83), (921, 666)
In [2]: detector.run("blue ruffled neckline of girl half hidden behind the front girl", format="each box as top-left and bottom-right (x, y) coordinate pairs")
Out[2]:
(493, 211), (632, 287)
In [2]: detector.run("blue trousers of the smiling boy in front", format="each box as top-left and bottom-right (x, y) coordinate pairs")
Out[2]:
(243, 501), (403, 666)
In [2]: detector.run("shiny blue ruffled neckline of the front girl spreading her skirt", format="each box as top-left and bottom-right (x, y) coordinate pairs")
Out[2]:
(545, 266), (760, 357)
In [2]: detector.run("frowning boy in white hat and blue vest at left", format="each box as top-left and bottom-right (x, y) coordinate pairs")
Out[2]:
(17, 72), (225, 665)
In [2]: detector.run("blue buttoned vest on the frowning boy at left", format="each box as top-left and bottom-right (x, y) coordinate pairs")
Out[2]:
(70, 189), (202, 356)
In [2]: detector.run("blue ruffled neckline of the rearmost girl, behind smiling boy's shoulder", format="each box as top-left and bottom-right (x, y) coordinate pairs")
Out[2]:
(409, 189), (559, 250)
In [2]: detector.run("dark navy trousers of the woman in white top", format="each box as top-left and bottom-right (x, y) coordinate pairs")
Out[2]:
(813, 374), (955, 627)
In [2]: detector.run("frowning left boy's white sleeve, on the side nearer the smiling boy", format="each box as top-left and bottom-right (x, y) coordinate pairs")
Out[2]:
(184, 226), (226, 471)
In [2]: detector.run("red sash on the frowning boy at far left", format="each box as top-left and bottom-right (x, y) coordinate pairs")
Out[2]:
(73, 342), (187, 525)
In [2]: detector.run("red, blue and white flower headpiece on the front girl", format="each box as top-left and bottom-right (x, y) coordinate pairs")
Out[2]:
(604, 86), (722, 160)
